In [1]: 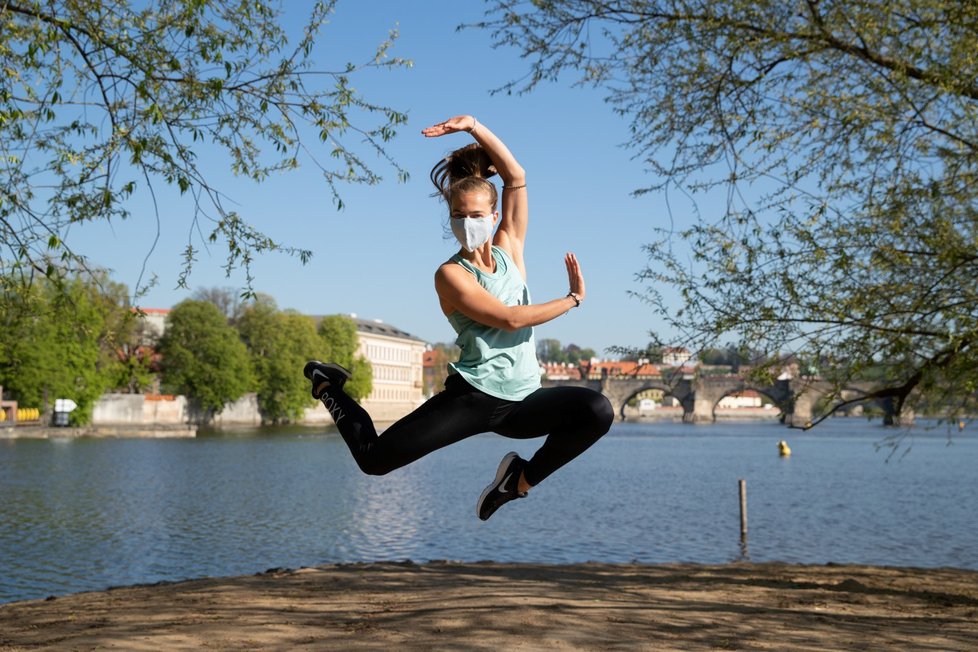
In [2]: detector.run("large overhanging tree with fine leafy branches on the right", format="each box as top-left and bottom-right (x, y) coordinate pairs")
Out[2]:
(481, 0), (978, 426)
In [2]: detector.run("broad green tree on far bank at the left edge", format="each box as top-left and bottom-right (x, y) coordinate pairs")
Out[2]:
(0, 272), (132, 425)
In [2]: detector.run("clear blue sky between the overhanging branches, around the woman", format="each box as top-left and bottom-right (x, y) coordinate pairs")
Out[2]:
(70, 0), (683, 354)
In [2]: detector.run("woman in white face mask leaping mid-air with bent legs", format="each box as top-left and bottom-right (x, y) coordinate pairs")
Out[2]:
(304, 115), (614, 520)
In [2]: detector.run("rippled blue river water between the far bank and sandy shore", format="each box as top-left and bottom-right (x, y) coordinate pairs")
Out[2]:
(0, 419), (978, 602)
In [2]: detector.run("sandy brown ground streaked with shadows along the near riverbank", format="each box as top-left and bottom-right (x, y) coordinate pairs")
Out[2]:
(0, 562), (978, 651)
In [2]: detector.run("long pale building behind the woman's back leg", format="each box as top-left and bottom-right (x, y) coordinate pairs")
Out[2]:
(351, 318), (427, 422)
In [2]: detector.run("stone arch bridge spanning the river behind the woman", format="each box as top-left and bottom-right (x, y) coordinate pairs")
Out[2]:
(543, 374), (913, 428)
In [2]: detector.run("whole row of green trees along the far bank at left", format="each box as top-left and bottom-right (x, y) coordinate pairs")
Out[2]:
(0, 275), (373, 426)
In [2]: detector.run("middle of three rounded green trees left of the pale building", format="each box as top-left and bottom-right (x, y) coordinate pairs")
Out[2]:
(237, 295), (326, 423)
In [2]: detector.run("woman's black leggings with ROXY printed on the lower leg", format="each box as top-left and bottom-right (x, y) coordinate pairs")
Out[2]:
(322, 374), (614, 485)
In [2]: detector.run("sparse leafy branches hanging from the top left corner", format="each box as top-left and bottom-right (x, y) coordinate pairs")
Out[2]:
(0, 0), (410, 291)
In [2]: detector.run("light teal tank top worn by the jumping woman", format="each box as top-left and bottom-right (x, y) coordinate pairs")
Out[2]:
(448, 246), (540, 401)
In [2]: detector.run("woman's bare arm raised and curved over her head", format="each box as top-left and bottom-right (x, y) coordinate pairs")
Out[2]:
(421, 115), (528, 279)
